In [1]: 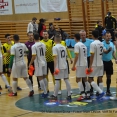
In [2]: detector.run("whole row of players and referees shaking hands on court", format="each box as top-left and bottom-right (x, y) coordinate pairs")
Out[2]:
(0, 30), (117, 101)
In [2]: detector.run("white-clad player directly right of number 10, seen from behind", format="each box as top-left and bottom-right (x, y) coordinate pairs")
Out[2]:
(72, 33), (90, 101)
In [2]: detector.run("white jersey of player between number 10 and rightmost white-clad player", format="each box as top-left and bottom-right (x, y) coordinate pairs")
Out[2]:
(74, 42), (87, 66)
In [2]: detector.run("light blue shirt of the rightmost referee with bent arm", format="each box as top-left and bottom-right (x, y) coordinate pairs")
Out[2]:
(102, 41), (114, 61)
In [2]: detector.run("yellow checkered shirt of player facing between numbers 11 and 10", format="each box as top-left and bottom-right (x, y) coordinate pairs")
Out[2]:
(41, 39), (54, 62)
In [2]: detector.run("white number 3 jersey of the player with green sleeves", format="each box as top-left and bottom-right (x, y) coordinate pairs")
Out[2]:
(11, 43), (28, 63)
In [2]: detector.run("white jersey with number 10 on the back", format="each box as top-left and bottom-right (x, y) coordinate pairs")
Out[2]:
(53, 44), (67, 69)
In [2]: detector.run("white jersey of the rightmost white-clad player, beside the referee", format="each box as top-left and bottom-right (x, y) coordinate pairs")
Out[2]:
(90, 40), (103, 66)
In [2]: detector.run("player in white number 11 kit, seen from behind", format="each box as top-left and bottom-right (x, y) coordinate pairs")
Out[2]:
(29, 33), (48, 98)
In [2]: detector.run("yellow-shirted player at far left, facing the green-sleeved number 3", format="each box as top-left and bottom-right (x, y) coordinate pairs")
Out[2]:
(2, 34), (22, 90)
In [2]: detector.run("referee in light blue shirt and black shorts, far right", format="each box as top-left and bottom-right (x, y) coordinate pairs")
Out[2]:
(102, 32), (117, 96)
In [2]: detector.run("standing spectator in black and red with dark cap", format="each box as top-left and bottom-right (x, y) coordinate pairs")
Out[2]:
(38, 18), (46, 40)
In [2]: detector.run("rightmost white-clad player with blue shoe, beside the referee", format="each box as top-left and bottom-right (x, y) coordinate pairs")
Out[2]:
(88, 30), (104, 99)
